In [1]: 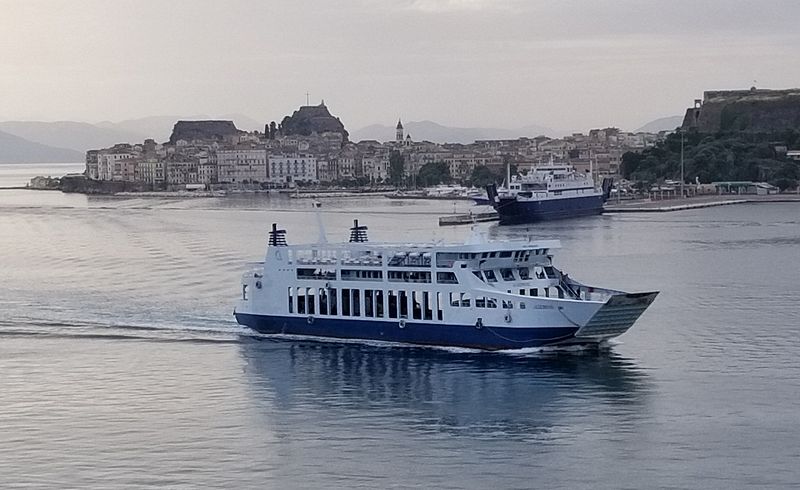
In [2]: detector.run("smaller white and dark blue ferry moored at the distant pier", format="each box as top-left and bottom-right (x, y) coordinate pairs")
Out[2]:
(487, 162), (612, 224)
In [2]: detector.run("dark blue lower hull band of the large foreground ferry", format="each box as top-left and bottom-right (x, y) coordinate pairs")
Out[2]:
(235, 313), (577, 350)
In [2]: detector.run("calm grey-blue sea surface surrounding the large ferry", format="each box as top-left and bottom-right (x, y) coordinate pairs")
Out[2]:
(0, 167), (800, 488)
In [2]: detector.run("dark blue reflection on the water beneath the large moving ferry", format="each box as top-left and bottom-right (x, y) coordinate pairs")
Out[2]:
(241, 339), (649, 438)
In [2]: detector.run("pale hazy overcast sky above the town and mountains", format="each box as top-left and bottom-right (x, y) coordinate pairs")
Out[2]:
(0, 0), (800, 130)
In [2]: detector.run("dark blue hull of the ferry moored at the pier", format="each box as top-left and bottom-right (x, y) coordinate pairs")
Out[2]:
(494, 194), (604, 224)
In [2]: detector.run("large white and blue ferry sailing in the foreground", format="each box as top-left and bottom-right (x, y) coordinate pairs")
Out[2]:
(234, 220), (658, 350)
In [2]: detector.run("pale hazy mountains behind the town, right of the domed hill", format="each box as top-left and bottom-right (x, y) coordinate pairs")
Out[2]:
(350, 121), (569, 144)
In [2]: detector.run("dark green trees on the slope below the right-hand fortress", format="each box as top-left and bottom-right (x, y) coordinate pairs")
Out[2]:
(621, 130), (800, 190)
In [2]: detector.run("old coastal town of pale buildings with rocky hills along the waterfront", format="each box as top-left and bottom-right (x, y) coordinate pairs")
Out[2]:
(79, 101), (666, 191)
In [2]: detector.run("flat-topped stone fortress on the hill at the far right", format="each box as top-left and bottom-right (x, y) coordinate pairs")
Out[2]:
(681, 87), (800, 133)
